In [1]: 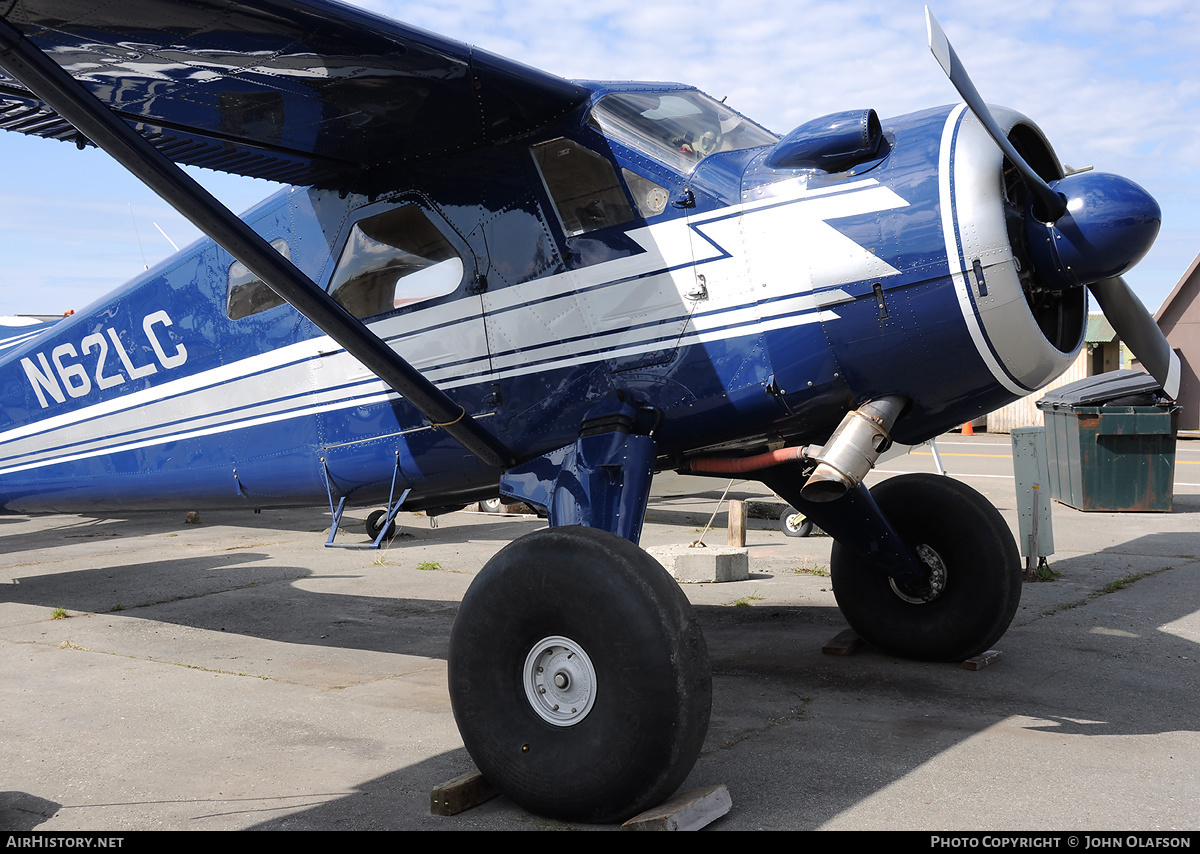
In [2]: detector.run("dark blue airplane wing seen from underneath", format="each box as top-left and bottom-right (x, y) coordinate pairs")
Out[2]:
(0, 0), (587, 188)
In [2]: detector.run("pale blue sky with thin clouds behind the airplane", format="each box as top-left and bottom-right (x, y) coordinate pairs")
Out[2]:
(0, 0), (1200, 315)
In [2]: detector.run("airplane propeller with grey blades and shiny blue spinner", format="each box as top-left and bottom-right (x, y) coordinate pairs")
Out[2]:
(925, 6), (1180, 398)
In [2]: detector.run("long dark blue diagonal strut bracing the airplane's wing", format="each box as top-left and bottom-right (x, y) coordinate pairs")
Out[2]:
(0, 18), (515, 468)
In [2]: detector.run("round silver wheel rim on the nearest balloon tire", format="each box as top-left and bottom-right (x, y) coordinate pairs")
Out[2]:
(524, 635), (596, 727)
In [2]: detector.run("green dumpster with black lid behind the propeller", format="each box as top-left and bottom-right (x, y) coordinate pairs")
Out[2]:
(1037, 371), (1180, 512)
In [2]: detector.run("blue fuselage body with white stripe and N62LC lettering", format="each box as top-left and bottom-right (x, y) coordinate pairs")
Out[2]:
(0, 86), (1075, 512)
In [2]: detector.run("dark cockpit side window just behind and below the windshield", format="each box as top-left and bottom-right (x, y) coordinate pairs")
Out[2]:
(530, 137), (634, 237)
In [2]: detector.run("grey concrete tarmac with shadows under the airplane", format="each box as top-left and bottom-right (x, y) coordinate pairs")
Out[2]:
(0, 435), (1200, 831)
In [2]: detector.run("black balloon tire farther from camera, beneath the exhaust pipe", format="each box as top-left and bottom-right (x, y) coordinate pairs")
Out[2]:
(830, 474), (1021, 661)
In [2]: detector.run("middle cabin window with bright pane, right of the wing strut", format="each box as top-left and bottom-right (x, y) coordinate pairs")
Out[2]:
(329, 205), (463, 318)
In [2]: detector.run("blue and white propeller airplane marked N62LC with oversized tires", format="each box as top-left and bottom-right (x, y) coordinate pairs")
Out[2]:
(0, 0), (1178, 822)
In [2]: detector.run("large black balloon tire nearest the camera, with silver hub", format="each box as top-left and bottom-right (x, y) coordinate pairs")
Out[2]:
(448, 527), (712, 823)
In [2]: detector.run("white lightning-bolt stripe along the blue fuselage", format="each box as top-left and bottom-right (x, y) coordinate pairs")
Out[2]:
(0, 179), (906, 474)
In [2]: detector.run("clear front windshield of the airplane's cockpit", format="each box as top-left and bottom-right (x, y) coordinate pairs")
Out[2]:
(592, 90), (779, 173)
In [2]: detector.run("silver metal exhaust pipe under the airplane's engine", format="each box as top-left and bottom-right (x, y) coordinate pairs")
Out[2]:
(800, 395), (908, 501)
